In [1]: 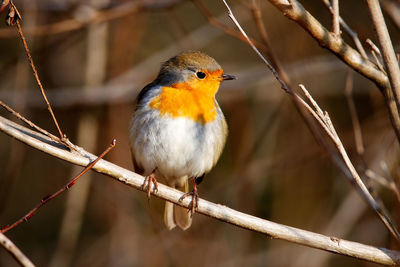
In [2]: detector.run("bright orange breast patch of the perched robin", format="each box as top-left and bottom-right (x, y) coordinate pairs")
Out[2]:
(150, 81), (219, 124)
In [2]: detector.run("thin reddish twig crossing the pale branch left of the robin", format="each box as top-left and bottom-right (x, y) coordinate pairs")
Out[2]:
(0, 139), (116, 233)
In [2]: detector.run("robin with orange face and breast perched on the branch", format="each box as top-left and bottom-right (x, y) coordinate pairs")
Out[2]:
(129, 51), (236, 230)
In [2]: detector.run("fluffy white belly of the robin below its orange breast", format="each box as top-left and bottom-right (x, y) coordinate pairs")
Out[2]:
(131, 107), (226, 180)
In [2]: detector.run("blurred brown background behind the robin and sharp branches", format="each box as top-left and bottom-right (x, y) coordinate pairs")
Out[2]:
(0, 0), (400, 267)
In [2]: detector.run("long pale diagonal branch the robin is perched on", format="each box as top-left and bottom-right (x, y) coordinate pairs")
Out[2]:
(0, 116), (400, 265)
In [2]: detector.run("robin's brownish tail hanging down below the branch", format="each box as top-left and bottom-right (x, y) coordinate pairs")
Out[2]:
(164, 179), (192, 230)
